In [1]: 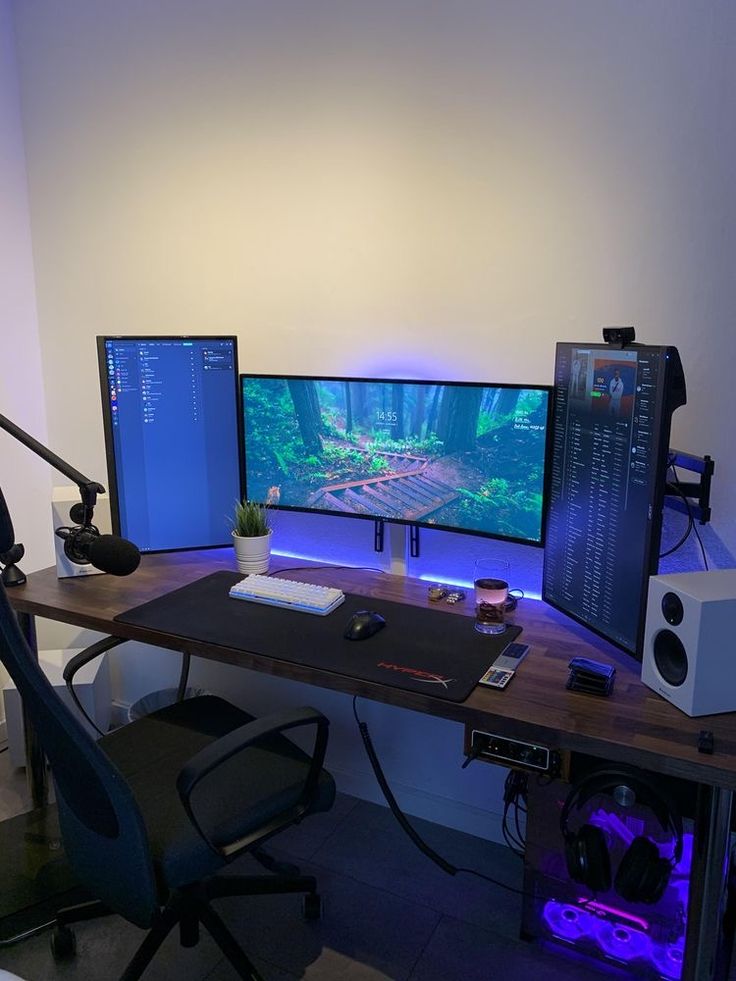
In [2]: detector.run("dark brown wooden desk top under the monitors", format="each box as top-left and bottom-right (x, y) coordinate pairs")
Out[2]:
(8, 548), (736, 790)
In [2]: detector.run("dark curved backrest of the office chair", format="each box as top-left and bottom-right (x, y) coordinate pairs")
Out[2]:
(0, 583), (159, 927)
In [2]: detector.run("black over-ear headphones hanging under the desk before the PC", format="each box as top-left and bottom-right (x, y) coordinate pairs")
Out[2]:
(560, 770), (683, 904)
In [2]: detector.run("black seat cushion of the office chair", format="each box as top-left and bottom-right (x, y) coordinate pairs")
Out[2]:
(99, 695), (335, 896)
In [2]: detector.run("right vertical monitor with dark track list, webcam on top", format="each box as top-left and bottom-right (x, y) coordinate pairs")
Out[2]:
(543, 343), (685, 656)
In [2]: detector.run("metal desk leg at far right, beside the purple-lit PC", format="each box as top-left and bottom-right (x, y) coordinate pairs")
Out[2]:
(682, 784), (733, 981)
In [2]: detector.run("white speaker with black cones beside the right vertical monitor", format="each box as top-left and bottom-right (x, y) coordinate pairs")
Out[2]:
(641, 569), (736, 716)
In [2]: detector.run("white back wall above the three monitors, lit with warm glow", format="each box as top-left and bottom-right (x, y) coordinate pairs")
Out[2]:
(8, 0), (736, 836)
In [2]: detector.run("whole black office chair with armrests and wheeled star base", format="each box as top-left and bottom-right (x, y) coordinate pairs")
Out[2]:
(0, 584), (335, 981)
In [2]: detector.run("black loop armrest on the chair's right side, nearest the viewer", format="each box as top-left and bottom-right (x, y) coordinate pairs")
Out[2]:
(176, 706), (330, 855)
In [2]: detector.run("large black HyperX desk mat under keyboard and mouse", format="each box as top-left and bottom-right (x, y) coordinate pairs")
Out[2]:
(115, 571), (521, 702)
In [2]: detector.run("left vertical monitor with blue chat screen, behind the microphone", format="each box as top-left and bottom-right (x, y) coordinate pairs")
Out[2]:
(97, 337), (241, 552)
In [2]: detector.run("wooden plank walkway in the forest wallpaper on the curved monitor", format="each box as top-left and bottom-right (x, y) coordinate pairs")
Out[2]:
(309, 453), (460, 521)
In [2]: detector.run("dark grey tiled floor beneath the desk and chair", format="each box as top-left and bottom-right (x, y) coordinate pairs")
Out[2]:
(0, 753), (627, 981)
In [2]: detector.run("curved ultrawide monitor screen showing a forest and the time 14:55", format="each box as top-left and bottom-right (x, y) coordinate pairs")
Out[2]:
(241, 374), (550, 545)
